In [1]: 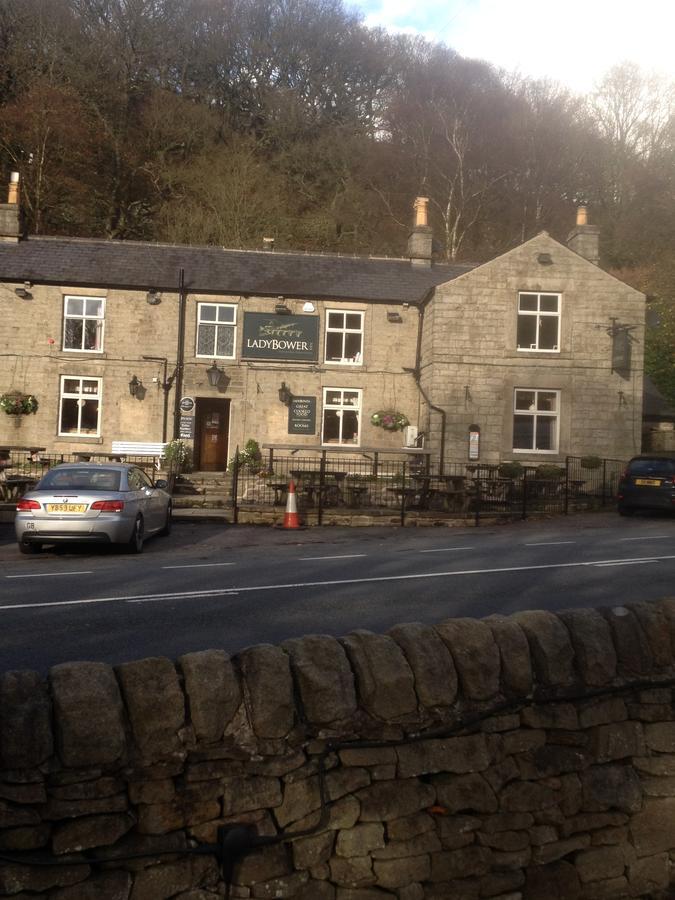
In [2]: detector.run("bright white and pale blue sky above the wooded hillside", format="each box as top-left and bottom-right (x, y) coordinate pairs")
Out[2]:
(347, 0), (675, 93)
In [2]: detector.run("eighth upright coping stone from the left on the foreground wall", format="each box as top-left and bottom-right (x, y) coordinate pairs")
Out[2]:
(388, 622), (457, 708)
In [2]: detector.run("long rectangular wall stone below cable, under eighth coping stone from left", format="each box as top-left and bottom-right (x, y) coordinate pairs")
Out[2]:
(396, 734), (490, 778)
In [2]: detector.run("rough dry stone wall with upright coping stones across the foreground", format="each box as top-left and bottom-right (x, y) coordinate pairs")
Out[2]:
(0, 599), (675, 900)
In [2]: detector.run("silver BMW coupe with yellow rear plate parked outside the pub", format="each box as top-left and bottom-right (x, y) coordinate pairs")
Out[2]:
(14, 463), (171, 553)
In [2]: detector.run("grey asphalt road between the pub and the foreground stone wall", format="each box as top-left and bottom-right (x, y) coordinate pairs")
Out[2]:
(0, 513), (675, 672)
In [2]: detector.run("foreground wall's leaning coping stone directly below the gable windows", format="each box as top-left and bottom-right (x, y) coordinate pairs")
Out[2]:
(512, 610), (575, 687)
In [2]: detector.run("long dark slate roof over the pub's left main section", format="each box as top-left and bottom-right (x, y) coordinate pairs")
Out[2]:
(0, 237), (475, 303)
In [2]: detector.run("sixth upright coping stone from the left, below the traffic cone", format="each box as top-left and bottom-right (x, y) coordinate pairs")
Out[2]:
(281, 634), (356, 725)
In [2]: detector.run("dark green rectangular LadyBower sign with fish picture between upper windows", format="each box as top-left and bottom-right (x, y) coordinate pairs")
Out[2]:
(241, 313), (319, 362)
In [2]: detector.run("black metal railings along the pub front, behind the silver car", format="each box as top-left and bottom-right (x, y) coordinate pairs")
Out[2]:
(0, 449), (625, 525)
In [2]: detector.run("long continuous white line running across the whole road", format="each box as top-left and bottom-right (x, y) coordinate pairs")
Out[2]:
(0, 555), (675, 612)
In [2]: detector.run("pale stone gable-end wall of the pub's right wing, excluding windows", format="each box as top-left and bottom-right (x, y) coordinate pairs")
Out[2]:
(423, 234), (645, 464)
